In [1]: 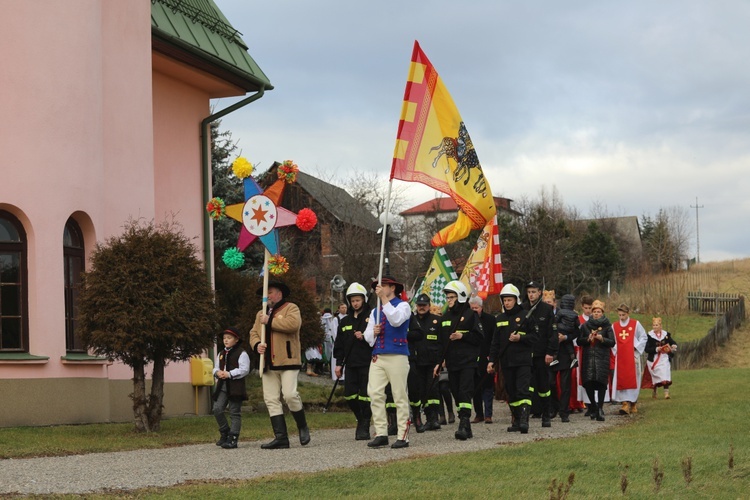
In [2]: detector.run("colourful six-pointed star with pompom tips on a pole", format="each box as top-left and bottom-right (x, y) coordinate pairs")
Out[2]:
(207, 158), (317, 274)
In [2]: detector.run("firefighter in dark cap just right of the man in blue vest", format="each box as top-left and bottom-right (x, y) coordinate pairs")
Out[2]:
(409, 293), (443, 432)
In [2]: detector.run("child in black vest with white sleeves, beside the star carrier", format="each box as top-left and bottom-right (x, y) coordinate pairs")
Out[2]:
(213, 328), (250, 449)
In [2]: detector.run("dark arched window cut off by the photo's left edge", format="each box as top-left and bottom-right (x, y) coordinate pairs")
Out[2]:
(0, 210), (29, 352)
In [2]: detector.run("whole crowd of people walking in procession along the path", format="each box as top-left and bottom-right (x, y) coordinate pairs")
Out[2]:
(213, 276), (677, 449)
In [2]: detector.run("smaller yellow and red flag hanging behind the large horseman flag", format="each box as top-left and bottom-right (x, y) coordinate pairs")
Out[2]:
(459, 216), (503, 299)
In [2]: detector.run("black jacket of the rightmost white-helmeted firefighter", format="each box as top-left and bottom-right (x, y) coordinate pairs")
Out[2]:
(490, 305), (537, 370)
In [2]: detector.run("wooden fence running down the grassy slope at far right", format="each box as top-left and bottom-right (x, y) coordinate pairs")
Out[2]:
(672, 294), (745, 370)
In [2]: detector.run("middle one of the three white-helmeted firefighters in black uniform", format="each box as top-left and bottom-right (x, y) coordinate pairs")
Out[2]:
(433, 280), (482, 441)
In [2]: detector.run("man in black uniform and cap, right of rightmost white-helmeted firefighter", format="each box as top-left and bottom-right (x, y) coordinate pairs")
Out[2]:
(523, 281), (560, 427)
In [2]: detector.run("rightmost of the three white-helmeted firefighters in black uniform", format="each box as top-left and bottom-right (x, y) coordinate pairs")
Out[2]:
(487, 283), (537, 434)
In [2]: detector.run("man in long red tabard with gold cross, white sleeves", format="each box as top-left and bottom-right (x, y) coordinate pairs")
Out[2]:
(612, 304), (648, 415)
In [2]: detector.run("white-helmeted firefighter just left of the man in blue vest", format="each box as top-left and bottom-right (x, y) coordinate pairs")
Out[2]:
(333, 283), (372, 441)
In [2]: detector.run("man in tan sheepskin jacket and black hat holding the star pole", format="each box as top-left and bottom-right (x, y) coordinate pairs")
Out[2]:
(250, 281), (310, 450)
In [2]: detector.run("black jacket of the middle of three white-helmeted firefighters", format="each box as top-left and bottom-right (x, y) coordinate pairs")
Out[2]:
(440, 302), (482, 371)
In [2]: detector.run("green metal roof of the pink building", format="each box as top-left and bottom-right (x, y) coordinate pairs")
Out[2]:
(151, 0), (273, 91)
